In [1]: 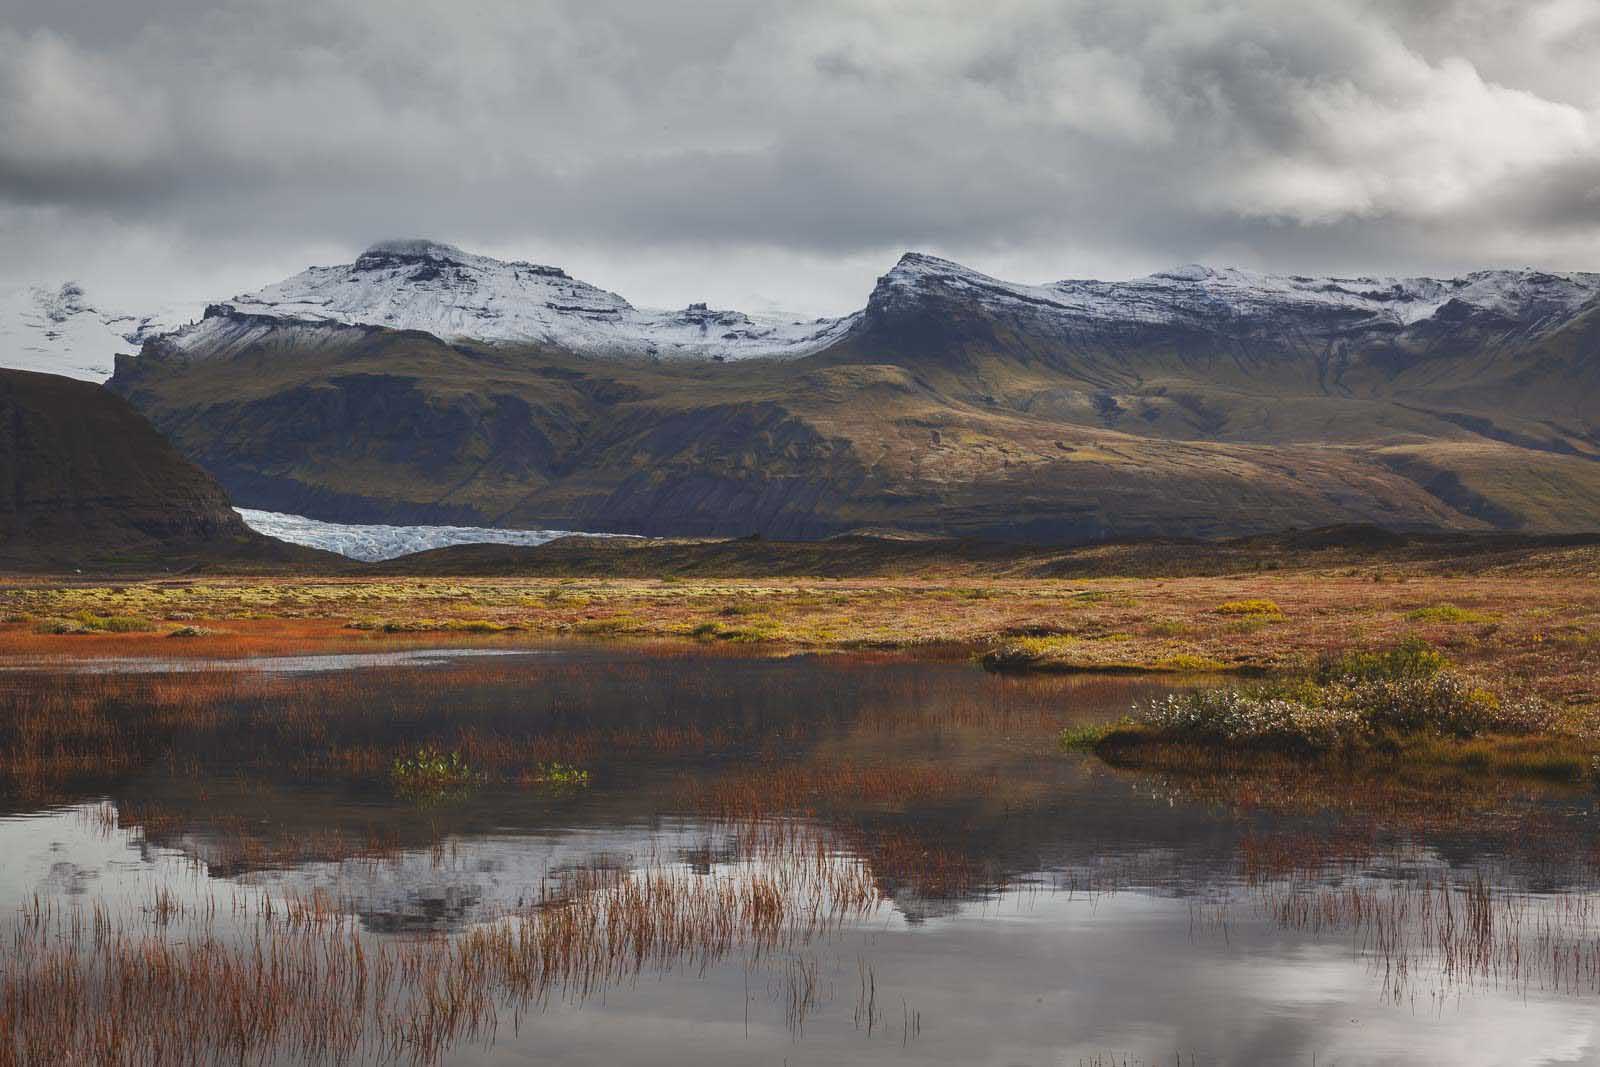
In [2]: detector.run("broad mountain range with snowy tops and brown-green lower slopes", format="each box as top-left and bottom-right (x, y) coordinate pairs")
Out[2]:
(72, 240), (1600, 541)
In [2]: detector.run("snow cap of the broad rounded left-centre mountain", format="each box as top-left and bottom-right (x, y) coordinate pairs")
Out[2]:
(166, 240), (851, 360)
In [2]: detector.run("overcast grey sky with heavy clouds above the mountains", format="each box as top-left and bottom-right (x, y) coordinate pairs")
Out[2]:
(0, 0), (1600, 315)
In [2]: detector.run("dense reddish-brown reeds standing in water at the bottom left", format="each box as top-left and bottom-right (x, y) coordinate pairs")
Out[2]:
(0, 827), (878, 1067)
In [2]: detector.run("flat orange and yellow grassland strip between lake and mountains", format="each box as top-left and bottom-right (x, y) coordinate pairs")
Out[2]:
(0, 572), (1600, 707)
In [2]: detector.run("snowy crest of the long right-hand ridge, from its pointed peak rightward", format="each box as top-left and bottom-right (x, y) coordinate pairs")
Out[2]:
(869, 253), (1600, 330)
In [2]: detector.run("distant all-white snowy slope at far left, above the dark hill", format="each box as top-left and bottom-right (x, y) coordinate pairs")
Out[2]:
(0, 282), (200, 382)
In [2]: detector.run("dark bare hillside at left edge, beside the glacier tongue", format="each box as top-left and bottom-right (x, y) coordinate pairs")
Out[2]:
(0, 371), (281, 563)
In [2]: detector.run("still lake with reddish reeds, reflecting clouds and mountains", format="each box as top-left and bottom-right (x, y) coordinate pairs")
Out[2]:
(0, 649), (1600, 1065)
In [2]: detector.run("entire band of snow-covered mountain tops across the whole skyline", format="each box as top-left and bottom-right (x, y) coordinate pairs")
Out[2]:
(34, 240), (1600, 381)
